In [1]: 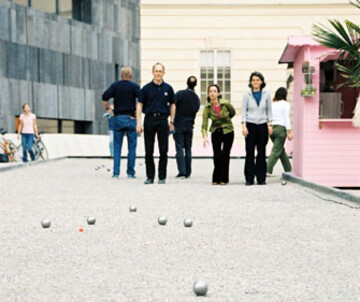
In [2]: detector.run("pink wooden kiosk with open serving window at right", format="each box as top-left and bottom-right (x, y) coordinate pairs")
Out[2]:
(279, 37), (360, 187)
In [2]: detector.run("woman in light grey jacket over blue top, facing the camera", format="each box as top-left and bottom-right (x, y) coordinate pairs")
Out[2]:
(242, 71), (273, 186)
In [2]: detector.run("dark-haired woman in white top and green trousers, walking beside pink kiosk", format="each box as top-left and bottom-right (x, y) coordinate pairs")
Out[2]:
(267, 87), (292, 176)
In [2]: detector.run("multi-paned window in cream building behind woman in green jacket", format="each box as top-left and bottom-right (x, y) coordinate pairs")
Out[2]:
(200, 50), (231, 104)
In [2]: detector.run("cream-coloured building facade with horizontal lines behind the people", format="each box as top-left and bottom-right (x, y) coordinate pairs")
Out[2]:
(141, 0), (360, 111)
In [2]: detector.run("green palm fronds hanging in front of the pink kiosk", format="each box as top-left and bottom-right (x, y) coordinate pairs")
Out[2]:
(312, 0), (360, 127)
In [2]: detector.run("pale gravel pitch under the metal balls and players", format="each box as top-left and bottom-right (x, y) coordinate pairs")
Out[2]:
(0, 159), (360, 302)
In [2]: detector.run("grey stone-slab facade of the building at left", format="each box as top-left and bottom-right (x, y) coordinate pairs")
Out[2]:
(0, 0), (140, 133)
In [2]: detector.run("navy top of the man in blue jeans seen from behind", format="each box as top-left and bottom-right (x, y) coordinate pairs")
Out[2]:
(102, 80), (140, 116)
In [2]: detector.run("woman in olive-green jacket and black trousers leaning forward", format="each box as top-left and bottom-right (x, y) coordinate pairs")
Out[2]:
(201, 84), (235, 185)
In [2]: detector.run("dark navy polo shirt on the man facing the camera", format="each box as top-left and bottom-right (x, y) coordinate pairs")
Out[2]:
(139, 82), (175, 114)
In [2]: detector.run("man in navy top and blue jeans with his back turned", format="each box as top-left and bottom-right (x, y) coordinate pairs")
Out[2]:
(102, 67), (140, 178)
